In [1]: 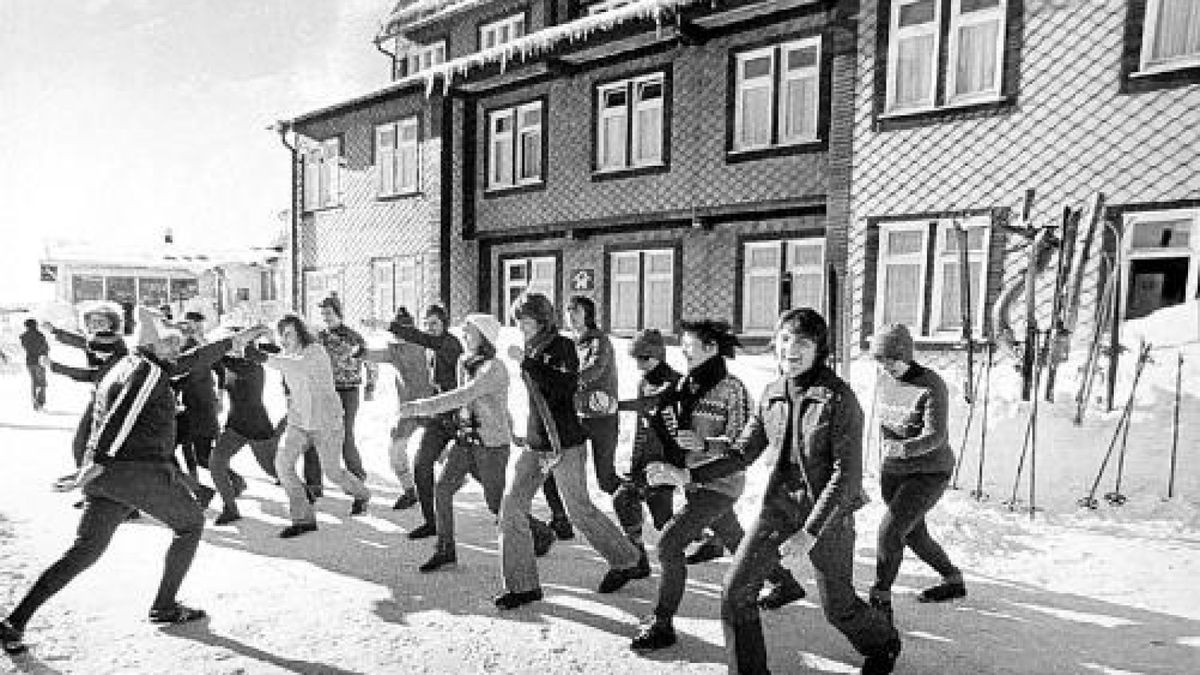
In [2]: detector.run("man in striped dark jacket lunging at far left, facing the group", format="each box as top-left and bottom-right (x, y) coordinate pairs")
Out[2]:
(0, 310), (262, 653)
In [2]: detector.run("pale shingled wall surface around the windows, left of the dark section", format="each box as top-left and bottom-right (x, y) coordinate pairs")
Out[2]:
(298, 94), (442, 317)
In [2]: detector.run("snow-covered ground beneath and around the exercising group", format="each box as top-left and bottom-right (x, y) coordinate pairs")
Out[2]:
(0, 304), (1200, 675)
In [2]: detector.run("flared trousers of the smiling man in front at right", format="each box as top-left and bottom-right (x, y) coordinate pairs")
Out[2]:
(721, 485), (899, 674)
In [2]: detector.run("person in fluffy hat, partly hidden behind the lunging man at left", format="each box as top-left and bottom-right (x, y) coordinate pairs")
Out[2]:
(42, 303), (128, 478)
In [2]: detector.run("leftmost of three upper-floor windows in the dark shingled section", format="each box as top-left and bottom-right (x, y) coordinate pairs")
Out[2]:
(487, 101), (542, 189)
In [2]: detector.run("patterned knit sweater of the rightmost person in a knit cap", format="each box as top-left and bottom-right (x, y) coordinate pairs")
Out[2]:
(876, 364), (954, 473)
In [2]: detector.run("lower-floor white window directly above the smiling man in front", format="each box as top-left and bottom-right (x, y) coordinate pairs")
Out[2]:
(742, 237), (826, 334)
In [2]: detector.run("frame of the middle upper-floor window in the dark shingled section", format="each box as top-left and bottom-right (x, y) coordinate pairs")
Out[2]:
(592, 68), (671, 170)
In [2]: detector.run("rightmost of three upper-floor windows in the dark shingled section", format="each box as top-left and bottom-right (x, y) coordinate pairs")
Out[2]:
(733, 37), (821, 150)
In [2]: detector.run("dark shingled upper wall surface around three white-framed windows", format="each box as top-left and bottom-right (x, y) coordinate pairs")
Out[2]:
(474, 14), (838, 233)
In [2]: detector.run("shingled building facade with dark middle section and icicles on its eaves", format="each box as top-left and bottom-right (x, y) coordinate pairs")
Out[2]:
(285, 0), (856, 345)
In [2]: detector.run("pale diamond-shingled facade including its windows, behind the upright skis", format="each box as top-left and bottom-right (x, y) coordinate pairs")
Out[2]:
(850, 0), (1200, 357)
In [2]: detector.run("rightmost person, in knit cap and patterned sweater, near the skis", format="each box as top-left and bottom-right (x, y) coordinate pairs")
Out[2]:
(870, 323), (967, 616)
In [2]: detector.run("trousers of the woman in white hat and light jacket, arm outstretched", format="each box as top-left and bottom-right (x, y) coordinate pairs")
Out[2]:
(433, 441), (509, 550)
